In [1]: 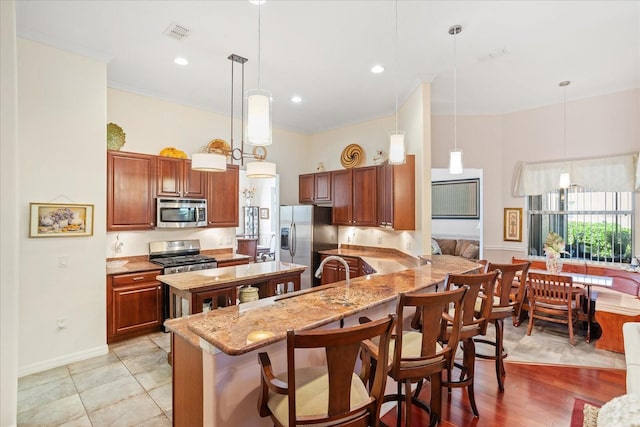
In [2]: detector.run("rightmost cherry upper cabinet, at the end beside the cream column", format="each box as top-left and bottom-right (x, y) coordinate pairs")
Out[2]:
(377, 154), (416, 230)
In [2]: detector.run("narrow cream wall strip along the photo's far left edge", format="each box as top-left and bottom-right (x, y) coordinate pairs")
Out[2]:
(0, 1), (20, 426)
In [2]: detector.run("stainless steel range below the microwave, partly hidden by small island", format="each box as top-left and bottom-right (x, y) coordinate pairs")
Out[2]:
(149, 240), (218, 323)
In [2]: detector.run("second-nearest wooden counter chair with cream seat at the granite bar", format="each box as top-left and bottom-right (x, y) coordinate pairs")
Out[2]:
(360, 287), (467, 427)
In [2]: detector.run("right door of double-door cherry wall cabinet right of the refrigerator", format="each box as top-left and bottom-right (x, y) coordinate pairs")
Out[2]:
(352, 166), (378, 227)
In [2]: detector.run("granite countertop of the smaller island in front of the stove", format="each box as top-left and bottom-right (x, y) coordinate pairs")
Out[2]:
(157, 261), (307, 291)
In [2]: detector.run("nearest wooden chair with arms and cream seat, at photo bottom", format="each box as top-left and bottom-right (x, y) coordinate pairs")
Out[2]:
(258, 314), (395, 427)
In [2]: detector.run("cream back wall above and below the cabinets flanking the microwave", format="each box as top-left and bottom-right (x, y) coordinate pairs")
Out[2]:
(105, 89), (309, 257)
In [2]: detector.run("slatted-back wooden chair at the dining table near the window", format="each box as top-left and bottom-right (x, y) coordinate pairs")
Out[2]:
(527, 273), (581, 345)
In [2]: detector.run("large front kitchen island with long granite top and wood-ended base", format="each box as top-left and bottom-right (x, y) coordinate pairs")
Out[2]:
(165, 256), (480, 427)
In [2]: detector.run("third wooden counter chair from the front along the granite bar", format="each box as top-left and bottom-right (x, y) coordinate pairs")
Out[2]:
(441, 271), (498, 417)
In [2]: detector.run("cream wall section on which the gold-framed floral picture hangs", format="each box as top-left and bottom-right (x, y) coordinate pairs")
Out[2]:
(13, 39), (107, 374)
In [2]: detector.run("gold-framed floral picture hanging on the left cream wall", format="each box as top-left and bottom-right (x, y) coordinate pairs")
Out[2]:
(29, 203), (93, 237)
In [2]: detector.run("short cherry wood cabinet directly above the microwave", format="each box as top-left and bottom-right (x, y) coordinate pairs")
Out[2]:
(157, 157), (207, 198)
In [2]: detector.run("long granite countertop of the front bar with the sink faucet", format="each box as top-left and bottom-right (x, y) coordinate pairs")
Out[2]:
(165, 253), (479, 355)
